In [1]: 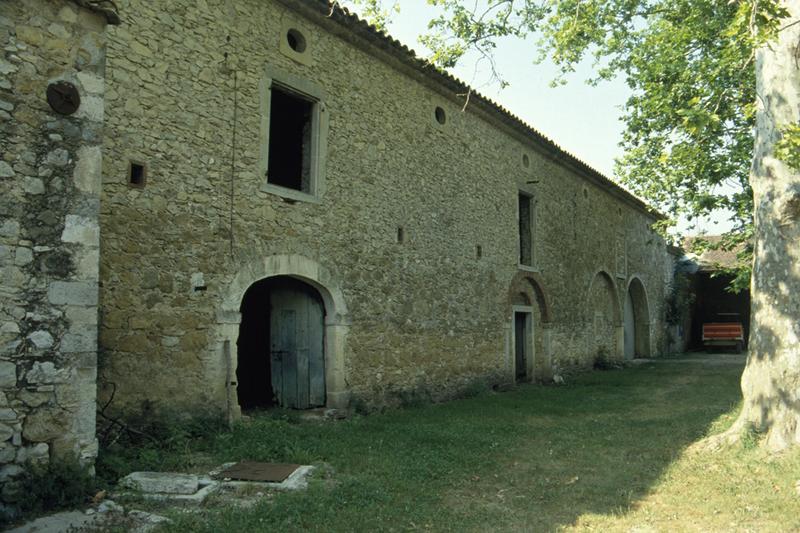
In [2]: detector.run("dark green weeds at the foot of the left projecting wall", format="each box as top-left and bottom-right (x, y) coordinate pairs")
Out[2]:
(17, 458), (95, 515)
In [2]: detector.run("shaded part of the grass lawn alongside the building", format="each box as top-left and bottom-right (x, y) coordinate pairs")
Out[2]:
(98, 358), (741, 531)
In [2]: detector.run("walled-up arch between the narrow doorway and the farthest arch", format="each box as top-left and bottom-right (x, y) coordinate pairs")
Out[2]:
(585, 270), (624, 362)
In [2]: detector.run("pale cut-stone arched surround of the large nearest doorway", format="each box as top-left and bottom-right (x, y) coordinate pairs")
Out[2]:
(214, 255), (350, 419)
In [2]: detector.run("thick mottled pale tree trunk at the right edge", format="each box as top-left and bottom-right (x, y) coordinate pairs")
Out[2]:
(729, 0), (800, 451)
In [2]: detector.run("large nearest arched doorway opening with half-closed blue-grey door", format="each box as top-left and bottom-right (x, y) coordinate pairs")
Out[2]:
(236, 276), (326, 410)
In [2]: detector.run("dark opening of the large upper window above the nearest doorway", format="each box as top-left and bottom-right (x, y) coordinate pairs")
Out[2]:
(267, 86), (315, 193)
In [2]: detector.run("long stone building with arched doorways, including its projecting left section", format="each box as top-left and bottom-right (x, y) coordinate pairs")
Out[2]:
(0, 0), (672, 502)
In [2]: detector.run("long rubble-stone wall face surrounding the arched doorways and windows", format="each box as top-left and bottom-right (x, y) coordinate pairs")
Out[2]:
(100, 0), (665, 411)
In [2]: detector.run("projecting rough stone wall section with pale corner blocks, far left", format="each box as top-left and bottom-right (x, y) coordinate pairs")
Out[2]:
(0, 0), (106, 510)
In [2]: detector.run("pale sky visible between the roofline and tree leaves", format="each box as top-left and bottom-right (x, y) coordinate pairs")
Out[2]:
(340, 0), (730, 233)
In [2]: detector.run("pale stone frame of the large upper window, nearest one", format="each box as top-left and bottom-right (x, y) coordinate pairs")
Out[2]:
(257, 65), (328, 204)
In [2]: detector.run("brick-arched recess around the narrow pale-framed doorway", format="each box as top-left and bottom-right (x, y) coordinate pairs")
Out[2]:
(506, 272), (553, 381)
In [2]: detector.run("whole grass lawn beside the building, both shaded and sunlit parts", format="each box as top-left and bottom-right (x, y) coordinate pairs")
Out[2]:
(99, 356), (800, 532)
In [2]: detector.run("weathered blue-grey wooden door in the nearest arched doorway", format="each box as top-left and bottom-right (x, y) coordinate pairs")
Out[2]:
(270, 288), (325, 409)
